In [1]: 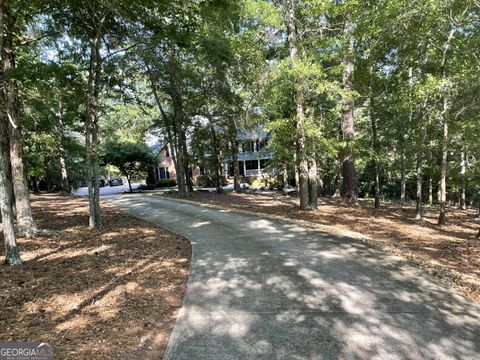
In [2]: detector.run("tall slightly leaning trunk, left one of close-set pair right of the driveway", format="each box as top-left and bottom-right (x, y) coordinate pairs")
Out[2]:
(285, 0), (311, 210)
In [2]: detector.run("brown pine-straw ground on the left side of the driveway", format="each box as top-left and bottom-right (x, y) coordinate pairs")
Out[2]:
(0, 195), (191, 359)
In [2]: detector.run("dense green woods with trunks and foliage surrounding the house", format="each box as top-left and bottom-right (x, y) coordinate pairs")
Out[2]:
(0, 0), (480, 265)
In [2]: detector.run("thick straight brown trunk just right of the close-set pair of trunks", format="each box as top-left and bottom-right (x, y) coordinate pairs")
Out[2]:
(341, 20), (357, 204)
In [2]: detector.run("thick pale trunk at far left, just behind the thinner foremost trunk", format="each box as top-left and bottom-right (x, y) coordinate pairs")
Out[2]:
(1, 3), (36, 237)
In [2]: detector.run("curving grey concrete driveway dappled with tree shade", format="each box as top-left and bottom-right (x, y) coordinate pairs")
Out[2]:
(109, 195), (480, 360)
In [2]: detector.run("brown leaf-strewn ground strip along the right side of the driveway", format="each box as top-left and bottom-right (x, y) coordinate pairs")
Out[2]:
(163, 192), (480, 303)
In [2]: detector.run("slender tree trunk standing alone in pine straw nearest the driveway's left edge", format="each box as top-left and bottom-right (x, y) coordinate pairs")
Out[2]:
(85, 33), (102, 228)
